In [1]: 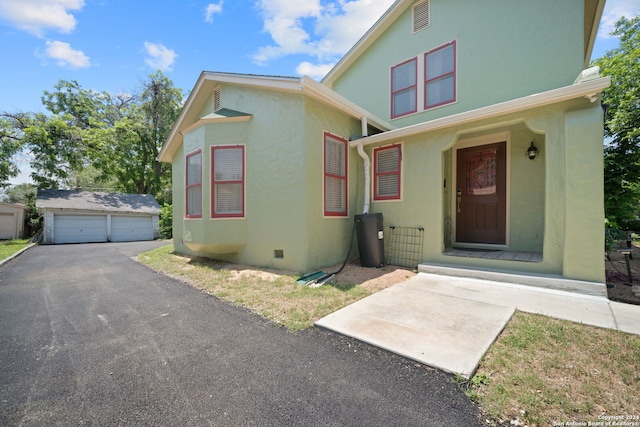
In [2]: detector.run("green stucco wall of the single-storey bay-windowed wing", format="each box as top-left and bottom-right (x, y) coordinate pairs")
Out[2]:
(173, 86), (359, 271)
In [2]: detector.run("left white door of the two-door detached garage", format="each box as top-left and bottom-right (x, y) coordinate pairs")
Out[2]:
(53, 215), (107, 243)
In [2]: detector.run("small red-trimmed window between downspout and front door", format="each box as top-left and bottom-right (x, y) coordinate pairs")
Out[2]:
(373, 144), (402, 200)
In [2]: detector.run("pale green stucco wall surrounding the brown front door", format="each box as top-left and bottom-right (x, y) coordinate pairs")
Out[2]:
(366, 99), (604, 283)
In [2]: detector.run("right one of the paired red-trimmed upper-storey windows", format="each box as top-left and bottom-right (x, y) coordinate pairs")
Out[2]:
(424, 41), (456, 110)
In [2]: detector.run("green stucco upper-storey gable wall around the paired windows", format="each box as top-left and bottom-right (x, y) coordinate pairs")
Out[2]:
(333, 0), (584, 127)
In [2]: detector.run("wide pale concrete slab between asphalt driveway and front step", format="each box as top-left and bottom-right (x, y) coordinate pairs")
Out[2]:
(316, 276), (514, 377)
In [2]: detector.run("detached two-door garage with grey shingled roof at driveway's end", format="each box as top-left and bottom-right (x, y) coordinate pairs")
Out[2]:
(36, 190), (160, 244)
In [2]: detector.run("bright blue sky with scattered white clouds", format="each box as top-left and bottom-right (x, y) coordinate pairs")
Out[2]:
(0, 0), (640, 184)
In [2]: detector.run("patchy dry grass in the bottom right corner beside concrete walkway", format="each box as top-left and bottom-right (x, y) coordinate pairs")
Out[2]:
(464, 312), (640, 427)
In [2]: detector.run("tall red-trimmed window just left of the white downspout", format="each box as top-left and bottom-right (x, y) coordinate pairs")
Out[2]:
(324, 132), (349, 216)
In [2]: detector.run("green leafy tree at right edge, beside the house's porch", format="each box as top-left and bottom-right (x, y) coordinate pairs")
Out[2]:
(595, 16), (640, 227)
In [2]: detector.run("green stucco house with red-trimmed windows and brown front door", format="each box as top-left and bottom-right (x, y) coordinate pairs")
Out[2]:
(159, 0), (610, 288)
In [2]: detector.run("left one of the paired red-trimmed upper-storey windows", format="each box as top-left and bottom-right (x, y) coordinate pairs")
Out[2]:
(391, 58), (418, 119)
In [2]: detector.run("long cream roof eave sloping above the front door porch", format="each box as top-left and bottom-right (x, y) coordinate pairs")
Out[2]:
(349, 76), (611, 147)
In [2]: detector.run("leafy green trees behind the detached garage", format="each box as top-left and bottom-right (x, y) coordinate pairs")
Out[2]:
(0, 71), (183, 204)
